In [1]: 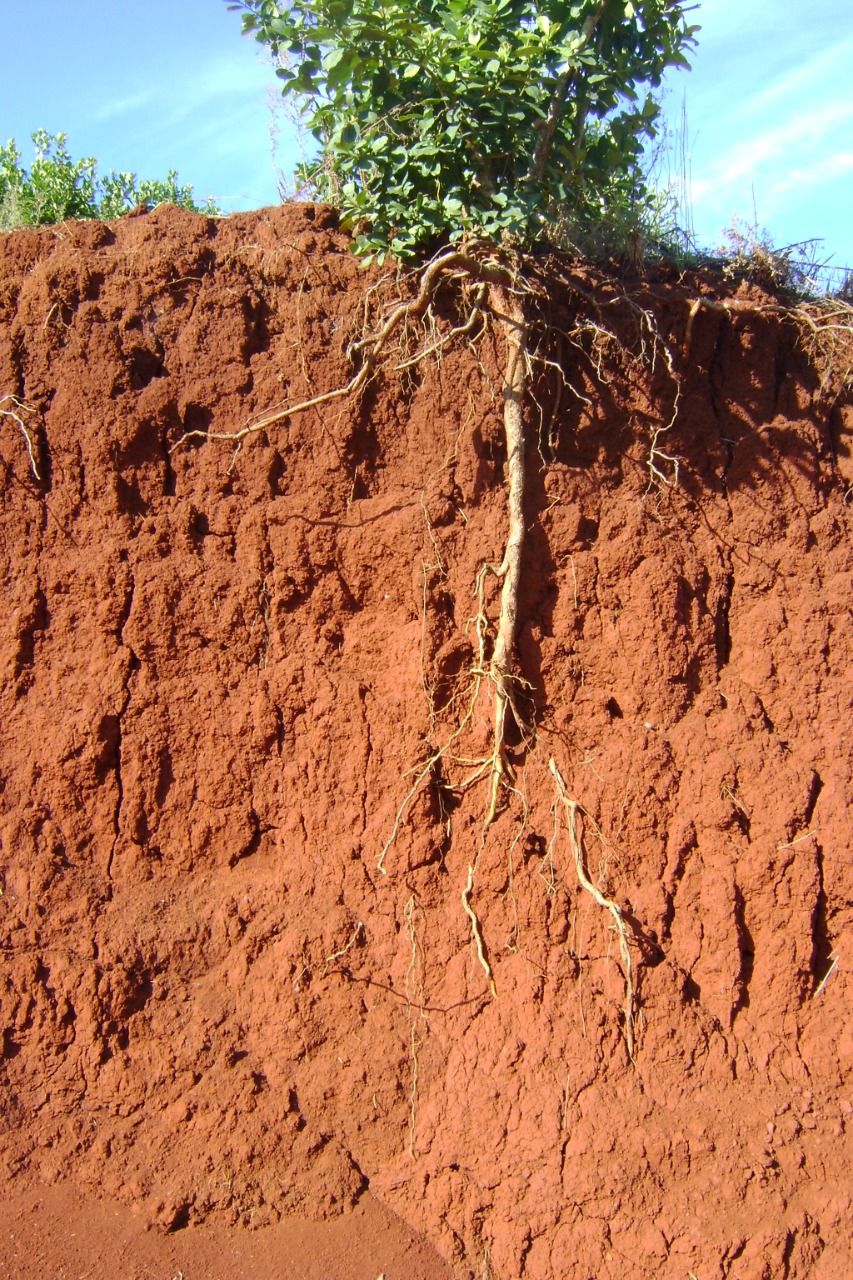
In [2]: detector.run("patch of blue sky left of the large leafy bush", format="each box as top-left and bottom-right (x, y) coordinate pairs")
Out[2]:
(0, 0), (278, 210)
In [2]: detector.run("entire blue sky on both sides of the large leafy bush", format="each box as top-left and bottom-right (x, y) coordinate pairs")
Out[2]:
(0, 0), (853, 277)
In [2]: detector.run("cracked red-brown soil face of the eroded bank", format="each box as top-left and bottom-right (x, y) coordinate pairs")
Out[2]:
(0, 205), (853, 1280)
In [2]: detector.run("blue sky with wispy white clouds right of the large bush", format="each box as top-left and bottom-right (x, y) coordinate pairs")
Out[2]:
(666, 0), (853, 280)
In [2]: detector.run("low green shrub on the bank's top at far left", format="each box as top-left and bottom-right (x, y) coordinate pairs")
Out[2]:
(0, 129), (219, 232)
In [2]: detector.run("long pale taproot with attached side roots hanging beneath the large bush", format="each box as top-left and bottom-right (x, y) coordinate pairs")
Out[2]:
(177, 244), (689, 873)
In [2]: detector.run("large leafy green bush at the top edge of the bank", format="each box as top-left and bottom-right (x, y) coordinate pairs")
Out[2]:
(229, 0), (698, 257)
